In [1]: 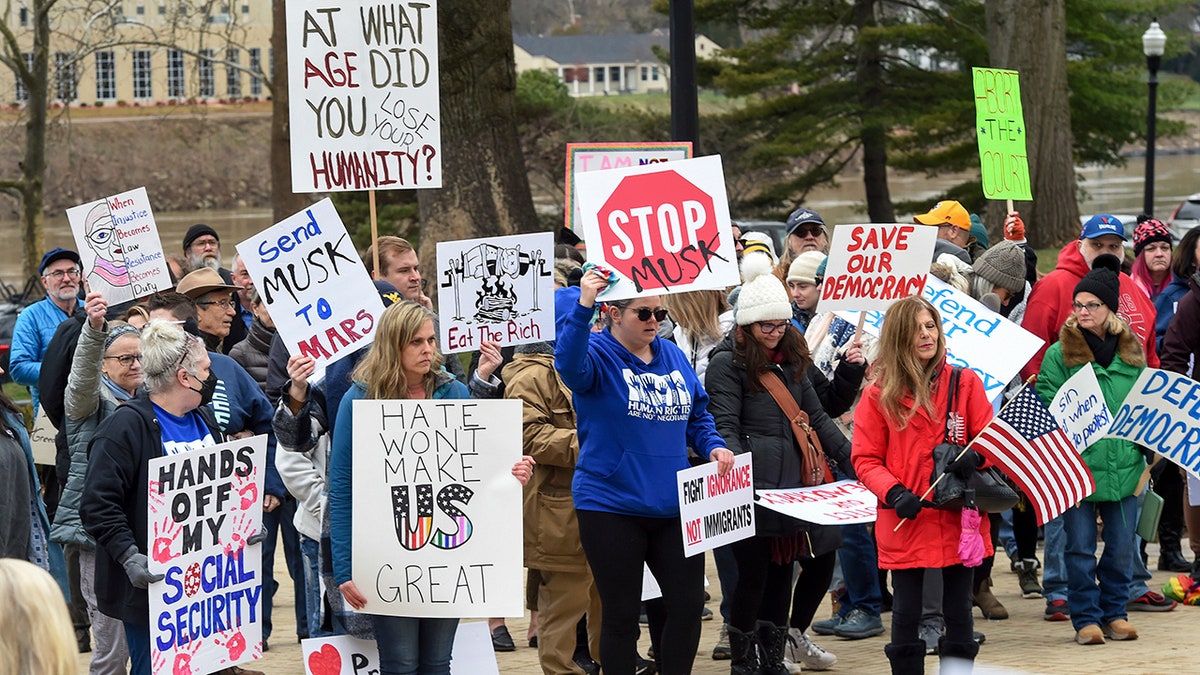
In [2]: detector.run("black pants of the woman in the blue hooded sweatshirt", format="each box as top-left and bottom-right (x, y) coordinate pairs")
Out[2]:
(576, 510), (704, 675)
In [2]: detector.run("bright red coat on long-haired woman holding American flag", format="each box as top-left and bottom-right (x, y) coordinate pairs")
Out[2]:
(851, 360), (992, 569)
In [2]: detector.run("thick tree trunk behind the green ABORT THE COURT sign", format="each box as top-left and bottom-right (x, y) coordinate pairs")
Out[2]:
(986, 0), (1079, 247)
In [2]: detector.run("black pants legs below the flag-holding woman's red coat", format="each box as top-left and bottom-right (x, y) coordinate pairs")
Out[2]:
(892, 565), (974, 645)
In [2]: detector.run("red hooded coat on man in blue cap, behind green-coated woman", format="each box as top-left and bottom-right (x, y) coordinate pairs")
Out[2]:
(1021, 241), (1158, 380)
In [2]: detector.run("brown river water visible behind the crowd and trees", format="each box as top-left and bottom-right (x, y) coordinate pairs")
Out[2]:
(0, 155), (1200, 287)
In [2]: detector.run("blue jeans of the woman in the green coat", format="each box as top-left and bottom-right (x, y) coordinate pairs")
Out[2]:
(1065, 495), (1138, 631)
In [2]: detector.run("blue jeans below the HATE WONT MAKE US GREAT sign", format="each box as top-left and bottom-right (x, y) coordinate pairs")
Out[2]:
(370, 614), (458, 675)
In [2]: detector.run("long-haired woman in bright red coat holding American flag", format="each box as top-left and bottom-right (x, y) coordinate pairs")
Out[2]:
(851, 295), (992, 675)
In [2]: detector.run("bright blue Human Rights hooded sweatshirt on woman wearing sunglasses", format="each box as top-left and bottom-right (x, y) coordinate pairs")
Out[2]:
(554, 296), (725, 518)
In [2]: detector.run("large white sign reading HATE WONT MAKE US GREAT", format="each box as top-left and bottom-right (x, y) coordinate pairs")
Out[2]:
(352, 399), (524, 619)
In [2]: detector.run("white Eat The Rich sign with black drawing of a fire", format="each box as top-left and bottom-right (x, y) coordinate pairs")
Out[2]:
(438, 232), (554, 354)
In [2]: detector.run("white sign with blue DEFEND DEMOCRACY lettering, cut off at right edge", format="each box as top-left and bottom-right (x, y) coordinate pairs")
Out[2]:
(1105, 368), (1200, 477)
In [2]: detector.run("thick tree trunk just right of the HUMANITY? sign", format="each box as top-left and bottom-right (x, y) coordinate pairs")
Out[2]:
(418, 0), (539, 277)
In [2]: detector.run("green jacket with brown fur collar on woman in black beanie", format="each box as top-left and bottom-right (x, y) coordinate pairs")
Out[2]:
(1036, 316), (1146, 502)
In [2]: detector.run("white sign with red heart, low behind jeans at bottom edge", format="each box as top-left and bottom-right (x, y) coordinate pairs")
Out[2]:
(300, 621), (500, 675)
